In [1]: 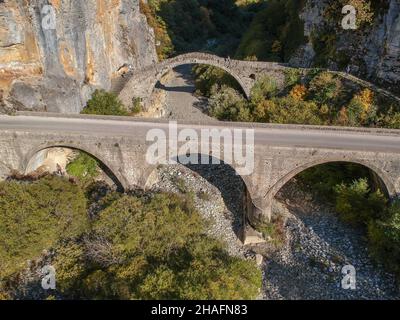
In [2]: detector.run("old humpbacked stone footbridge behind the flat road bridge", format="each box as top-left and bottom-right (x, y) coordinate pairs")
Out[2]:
(119, 52), (286, 106)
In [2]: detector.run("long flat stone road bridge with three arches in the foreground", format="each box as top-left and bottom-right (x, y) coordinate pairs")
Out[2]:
(0, 115), (400, 241)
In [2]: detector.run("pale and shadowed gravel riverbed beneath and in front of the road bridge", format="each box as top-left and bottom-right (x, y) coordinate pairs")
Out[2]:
(149, 164), (400, 300)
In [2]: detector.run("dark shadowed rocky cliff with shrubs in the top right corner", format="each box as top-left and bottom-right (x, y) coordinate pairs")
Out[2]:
(290, 0), (400, 93)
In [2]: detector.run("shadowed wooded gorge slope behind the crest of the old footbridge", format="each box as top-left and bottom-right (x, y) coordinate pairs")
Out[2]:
(140, 0), (263, 59)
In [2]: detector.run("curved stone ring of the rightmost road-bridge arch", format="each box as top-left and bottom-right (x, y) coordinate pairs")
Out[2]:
(264, 157), (396, 202)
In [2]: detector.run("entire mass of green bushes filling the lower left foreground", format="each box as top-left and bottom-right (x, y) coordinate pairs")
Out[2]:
(0, 176), (261, 299)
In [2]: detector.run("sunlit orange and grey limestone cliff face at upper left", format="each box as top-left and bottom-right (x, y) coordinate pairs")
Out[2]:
(0, 0), (157, 113)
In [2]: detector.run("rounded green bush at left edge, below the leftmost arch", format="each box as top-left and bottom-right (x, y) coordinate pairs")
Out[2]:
(0, 176), (88, 286)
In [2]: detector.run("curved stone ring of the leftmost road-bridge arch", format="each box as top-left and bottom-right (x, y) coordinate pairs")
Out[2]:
(22, 143), (127, 191)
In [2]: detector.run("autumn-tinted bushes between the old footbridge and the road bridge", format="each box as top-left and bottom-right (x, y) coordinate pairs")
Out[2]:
(203, 69), (400, 128)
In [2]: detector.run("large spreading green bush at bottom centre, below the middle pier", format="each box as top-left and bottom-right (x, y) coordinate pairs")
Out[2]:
(55, 194), (261, 299)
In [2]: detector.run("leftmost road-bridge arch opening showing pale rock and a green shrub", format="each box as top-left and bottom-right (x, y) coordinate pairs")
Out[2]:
(24, 145), (124, 191)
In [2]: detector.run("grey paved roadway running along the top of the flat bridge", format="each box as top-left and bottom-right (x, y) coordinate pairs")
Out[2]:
(0, 116), (400, 153)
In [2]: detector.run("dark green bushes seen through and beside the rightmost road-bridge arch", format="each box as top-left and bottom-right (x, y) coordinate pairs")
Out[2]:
(299, 163), (400, 277)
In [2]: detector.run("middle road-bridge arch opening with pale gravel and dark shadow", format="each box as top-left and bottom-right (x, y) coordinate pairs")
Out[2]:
(146, 153), (253, 240)
